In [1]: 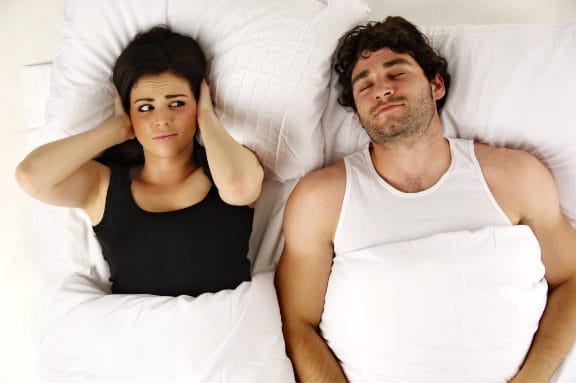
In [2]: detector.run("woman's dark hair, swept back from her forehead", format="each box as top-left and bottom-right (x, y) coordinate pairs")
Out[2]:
(112, 26), (206, 113)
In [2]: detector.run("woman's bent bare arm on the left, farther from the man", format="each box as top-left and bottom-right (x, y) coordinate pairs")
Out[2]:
(16, 104), (133, 213)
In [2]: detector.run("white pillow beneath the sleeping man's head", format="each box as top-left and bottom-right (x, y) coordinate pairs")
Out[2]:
(322, 24), (576, 220)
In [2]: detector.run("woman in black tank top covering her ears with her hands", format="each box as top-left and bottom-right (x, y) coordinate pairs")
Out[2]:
(16, 27), (263, 296)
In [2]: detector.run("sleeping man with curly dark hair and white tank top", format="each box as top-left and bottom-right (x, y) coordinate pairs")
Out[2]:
(276, 17), (576, 383)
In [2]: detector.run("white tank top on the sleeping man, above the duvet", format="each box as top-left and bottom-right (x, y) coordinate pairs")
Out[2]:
(334, 138), (512, 255)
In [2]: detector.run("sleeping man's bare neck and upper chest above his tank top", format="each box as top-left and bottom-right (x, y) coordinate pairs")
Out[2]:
(370, 130), (451, 193)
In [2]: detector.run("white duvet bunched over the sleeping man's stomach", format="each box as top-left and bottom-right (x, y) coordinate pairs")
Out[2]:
(321, 226), (547, 383)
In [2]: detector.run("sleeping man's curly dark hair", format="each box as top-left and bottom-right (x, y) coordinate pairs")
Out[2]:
(334, 16), (450, 110)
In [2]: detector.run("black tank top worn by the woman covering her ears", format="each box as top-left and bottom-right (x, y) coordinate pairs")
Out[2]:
(93, 167), (254, 296)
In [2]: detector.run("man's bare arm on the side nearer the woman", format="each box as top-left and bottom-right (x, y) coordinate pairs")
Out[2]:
(275, 164), (346, 382)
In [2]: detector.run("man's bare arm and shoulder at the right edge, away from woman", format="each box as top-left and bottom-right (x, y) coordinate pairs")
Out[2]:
(479, 149), (576, 383)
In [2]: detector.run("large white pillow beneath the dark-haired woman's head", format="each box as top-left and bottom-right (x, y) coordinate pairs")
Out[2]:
(46, 0), (369, 181)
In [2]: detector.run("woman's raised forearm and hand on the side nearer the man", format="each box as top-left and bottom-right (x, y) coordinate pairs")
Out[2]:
(197, 81), (264, 205)
